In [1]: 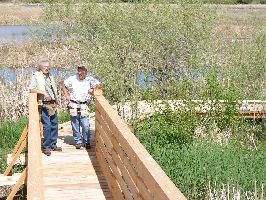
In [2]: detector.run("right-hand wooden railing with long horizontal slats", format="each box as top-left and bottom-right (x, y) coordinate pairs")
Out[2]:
(95, 91), (186, 200)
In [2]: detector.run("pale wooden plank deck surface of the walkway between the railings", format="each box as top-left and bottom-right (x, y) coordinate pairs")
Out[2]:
(42, 120), (112, 200)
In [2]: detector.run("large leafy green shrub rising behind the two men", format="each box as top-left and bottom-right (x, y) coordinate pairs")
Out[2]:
(46, 1), (218, 103)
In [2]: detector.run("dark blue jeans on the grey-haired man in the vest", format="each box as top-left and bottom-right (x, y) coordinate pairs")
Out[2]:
(41, 108), (58, 150)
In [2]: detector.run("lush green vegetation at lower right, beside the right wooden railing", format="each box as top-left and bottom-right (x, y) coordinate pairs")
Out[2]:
(135, 111), (266, 199)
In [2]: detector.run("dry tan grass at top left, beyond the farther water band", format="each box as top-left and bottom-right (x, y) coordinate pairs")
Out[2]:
(0, 3), (43, 25)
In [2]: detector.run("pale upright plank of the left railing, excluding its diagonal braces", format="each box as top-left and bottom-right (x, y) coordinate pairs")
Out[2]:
(27, 93), (44, 200)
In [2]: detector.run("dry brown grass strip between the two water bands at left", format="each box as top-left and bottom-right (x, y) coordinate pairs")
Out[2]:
(0, 40), (83, 68)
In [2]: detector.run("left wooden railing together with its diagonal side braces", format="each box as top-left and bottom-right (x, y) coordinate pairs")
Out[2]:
(3, 93), (44, 200)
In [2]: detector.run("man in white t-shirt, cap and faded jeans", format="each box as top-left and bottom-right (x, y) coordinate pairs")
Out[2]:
(62, 65), (102, 149)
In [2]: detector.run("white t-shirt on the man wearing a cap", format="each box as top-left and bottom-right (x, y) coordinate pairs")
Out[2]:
(64, 75), (100, 102)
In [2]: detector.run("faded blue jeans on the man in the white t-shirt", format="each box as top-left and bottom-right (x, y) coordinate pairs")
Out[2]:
(70, 112), (90, 144)
